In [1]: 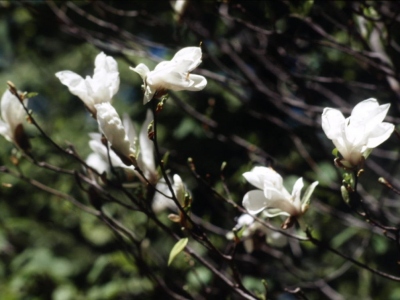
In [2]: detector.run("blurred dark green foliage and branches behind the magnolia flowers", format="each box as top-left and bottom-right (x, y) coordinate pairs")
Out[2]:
(0, 0), (400, 300)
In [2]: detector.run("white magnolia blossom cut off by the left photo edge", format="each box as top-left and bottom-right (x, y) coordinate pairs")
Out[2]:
(0, 90), (28, 144)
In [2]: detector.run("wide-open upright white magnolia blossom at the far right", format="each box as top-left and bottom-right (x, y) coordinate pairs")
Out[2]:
(322, 98), (394, 168)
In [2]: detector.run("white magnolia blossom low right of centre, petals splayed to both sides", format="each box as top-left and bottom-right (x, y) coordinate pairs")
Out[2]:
(243, 167), (318, 217)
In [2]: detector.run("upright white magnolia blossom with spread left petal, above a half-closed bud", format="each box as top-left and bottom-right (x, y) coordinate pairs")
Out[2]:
(56, 52), (119, 116)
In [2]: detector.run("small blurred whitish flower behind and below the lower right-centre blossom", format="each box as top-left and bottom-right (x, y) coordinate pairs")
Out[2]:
(227, 214), (287, 253)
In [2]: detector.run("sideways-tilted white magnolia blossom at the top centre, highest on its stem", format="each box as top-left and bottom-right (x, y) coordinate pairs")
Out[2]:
(130, 47), (207, 104)
